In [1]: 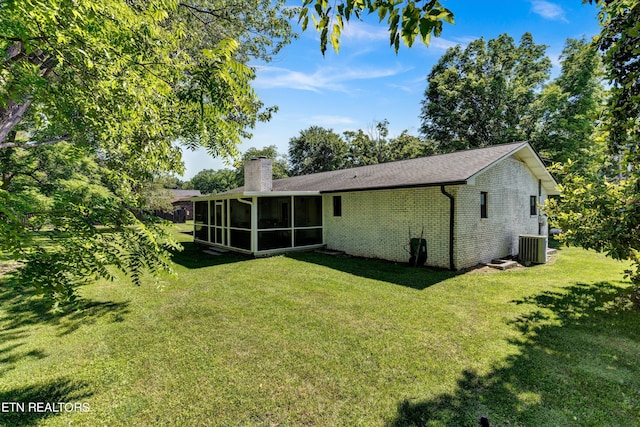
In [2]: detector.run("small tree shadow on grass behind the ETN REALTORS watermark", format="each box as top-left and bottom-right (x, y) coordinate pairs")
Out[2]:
(0, 378), (91, 427)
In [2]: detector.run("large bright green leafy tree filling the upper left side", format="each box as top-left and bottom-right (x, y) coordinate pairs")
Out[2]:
(0, 0), (292, 308)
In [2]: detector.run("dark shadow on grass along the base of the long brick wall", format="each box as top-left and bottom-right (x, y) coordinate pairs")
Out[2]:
(287, 252), (460, 290)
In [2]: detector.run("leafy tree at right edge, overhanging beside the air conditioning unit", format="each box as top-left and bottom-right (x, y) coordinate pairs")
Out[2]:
(548, 0), (640, 305)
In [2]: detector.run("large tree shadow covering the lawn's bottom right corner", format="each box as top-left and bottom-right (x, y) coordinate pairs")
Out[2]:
(388, 282), (640, 426)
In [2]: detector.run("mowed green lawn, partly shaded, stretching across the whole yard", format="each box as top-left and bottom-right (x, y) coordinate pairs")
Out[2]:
(0, 234), (640, 426)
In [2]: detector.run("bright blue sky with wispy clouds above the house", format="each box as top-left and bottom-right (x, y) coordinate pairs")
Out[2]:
(183, 0), (599, 179)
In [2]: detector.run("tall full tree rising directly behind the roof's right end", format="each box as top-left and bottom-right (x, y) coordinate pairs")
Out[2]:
(420, 33), (551, 152)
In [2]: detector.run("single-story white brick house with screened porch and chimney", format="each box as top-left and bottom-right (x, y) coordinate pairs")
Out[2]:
(192, 142), (558, 269)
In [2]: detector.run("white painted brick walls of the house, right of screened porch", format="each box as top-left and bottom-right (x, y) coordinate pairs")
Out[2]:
(323, 158), (546, 269)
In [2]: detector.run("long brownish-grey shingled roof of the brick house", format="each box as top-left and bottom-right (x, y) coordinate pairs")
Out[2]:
(222, 142), (555, 194)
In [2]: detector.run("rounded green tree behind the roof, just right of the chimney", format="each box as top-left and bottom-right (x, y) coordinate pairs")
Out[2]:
(289, 126), (347, 175)
